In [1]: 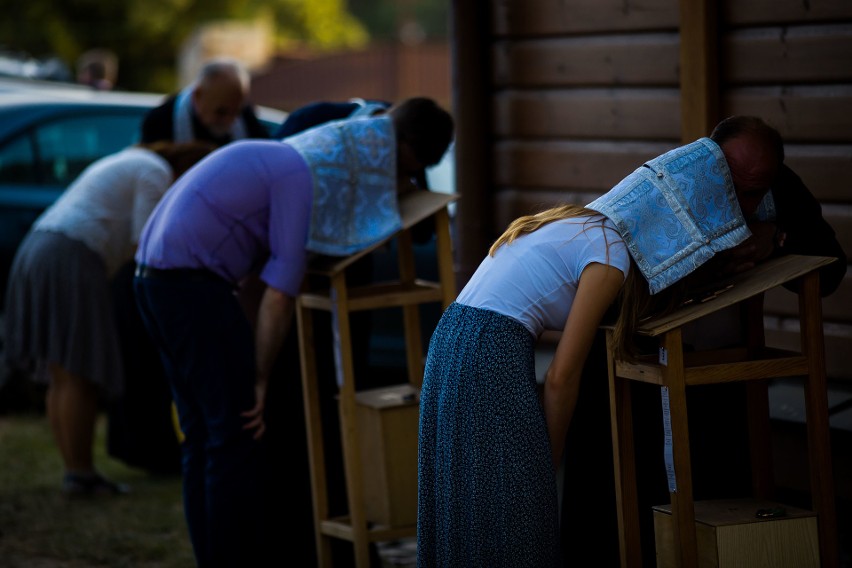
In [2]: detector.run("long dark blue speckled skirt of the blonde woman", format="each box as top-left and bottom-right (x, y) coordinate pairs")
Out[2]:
(417, 303), (561, 568)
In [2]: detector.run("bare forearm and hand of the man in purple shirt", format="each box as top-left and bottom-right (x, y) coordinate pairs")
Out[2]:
(242, 286), (296, 439)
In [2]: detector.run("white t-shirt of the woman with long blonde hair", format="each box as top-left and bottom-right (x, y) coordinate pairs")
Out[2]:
(456, 215), (630, 338)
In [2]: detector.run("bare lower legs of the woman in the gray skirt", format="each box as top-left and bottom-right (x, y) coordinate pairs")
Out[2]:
(47, 363), (98, 475)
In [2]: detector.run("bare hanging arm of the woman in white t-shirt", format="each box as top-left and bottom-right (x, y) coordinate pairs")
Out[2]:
(543, 262), (624, 470)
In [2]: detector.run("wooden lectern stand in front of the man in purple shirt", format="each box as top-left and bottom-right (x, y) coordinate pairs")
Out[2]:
(296, 191), (458, 568)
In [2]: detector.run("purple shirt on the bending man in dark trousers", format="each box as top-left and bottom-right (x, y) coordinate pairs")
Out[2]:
(136, 140), (313, 296)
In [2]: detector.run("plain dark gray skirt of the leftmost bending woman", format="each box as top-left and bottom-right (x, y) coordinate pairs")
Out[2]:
(5, 231), (124, 396)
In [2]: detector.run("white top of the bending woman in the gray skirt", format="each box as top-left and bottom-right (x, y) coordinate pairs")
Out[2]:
(33, 147), (172, 275)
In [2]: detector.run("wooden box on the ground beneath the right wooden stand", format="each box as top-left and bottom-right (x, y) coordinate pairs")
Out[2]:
(654, 499), (819, 568)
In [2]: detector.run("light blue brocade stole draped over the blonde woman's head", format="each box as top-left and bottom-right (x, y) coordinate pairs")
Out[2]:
(586, 138), (751, 294)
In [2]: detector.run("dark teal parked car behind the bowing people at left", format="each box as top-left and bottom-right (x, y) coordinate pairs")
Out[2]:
(0, 78), (286, 306)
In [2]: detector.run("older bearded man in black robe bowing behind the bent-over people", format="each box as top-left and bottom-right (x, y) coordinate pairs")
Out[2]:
(115, 58), (268, 474)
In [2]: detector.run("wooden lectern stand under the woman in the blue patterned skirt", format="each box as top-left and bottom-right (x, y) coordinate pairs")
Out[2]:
(607, 255), (839, 568)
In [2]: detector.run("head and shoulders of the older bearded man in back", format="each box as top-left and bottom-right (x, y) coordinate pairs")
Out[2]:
(142, 58), (269, 146)
